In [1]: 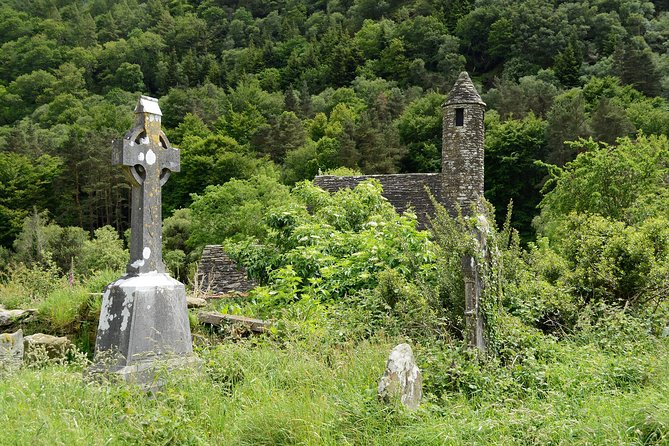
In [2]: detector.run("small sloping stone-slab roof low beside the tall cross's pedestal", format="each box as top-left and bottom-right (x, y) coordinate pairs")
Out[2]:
(197, 245), (256, 294)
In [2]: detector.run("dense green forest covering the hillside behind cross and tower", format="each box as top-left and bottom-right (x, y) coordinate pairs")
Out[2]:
(0, 0), (669, 253)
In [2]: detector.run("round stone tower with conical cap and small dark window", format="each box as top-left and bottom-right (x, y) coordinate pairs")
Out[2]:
(441, 71), (485, 214)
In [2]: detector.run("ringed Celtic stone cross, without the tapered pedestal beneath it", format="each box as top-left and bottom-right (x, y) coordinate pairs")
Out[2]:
(112, 96), (180, 275)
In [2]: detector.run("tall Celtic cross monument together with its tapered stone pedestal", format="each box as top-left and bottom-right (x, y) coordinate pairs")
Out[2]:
(93, 96), (193, 383)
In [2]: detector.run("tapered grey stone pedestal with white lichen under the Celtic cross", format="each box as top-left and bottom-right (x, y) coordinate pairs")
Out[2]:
(91, 273), (197, 385)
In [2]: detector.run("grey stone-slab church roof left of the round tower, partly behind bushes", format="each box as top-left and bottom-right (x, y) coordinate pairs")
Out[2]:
(314, 173), (444, 228)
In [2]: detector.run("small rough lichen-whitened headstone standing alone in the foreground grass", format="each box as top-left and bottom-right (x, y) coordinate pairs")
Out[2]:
(378, 344), (423, 409)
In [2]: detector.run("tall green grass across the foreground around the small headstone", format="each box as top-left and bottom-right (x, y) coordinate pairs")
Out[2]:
(0, 339), (669, 445)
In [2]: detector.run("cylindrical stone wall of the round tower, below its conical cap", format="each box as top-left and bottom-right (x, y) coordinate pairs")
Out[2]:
(441, 103), (485, 214)
